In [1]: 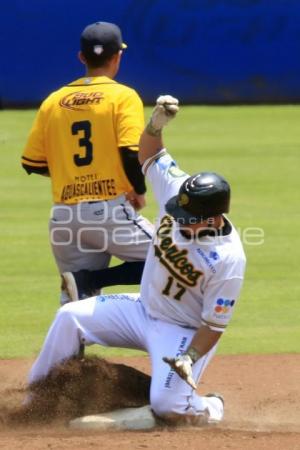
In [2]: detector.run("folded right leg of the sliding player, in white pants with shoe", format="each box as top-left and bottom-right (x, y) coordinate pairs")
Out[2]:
(147, 321), (224, 425)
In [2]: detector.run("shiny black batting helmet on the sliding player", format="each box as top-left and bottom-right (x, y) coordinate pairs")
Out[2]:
(165, 172), (230, 224)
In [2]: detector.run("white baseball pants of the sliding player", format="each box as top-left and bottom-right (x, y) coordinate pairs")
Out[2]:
(29, 294), (223, 423)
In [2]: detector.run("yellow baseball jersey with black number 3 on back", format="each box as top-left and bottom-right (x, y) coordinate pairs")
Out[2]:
(22, 76), (144, 204)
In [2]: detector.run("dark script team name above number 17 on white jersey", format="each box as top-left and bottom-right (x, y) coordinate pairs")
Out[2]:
(154, 216), (202, 286)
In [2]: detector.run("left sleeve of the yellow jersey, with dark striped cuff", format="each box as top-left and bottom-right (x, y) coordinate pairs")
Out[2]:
(21, 105), (48, 173)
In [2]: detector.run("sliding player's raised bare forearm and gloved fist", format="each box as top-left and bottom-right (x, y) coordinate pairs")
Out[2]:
(139, 95), (179, 164)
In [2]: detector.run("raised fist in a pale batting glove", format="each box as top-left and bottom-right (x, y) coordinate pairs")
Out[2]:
(150, 95), (179, 131)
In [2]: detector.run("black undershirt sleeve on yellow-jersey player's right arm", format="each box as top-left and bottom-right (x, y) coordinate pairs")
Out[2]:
(120, 147), (146, 195)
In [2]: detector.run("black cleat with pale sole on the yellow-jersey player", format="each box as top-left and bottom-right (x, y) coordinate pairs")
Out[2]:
(61, 270), (96, 302)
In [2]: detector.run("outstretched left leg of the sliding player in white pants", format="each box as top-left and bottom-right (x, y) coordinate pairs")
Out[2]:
(29, 294), (147, 383)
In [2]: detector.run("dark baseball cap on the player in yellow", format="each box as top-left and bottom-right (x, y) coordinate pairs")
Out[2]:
(80, 22), (127, 56)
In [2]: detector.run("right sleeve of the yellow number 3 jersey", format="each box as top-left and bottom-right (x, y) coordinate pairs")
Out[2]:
(117, 89), (144, 151)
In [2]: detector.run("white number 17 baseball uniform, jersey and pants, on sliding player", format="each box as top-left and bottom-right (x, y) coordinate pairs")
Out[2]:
(29, 151), (245, 422)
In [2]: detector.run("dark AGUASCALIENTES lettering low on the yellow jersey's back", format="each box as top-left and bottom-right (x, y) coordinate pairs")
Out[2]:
(61, 176), (117, 202)
